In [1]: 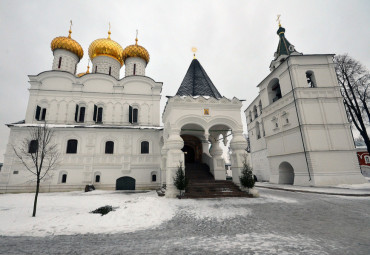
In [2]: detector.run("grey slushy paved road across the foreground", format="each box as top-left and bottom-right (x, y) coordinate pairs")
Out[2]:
(0, 189), (370, 255)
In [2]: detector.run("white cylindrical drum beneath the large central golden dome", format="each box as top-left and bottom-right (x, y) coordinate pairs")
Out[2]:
(91, 56), (121, 80)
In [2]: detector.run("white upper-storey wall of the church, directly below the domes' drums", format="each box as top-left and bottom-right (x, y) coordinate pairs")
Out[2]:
(25, 72), (162, 126)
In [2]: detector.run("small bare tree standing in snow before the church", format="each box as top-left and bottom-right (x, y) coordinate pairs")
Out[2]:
(13, 123), (59, 217)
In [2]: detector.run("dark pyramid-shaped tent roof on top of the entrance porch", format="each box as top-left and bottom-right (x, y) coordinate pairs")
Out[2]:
(176, 59), (222, 99)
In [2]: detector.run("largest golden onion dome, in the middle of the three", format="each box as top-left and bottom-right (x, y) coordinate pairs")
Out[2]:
(89, 30), (123, 66)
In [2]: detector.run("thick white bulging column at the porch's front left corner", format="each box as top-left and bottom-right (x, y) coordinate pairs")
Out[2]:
(165, 130), (185, 198)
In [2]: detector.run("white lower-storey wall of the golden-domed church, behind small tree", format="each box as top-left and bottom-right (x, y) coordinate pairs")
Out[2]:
(0, 127), (162, 192)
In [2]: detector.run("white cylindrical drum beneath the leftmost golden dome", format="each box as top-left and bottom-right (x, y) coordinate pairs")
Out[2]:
(52, 49), (80, 74)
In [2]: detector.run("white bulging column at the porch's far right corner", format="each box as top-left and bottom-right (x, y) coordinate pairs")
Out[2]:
(230, 130), (248, 186)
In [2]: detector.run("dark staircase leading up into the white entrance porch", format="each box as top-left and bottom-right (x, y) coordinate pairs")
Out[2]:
(184, 163), (251, 198)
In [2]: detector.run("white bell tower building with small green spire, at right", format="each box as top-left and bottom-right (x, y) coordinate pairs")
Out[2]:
(245, 24), (365, 186)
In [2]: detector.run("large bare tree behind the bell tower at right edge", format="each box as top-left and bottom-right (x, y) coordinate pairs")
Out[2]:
(334, 54), (370, 153)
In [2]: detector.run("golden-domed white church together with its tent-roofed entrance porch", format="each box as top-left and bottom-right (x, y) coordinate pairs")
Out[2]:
(0, 24), (246, 197)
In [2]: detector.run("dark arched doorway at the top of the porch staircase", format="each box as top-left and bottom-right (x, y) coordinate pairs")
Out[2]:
(181, 135), (203, 164)
